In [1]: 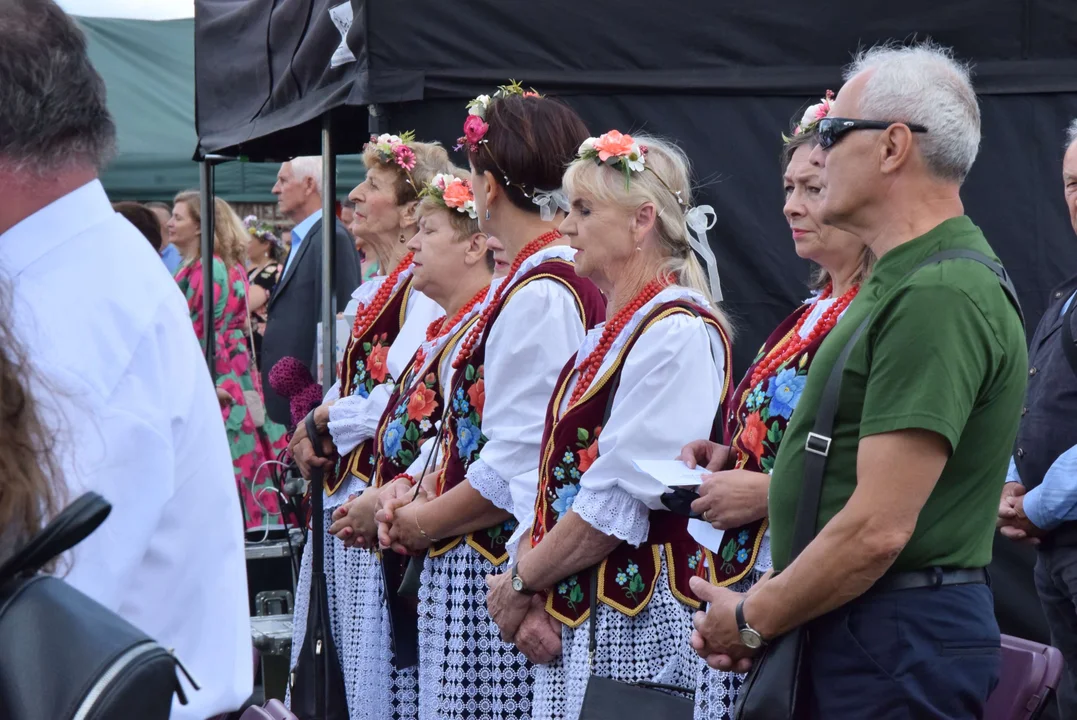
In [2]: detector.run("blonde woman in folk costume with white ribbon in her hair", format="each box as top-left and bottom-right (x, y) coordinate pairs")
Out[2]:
(487, 130), (729, 720)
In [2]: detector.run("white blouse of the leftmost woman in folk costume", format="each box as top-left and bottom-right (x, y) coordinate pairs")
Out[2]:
(325, 268), (445, 509)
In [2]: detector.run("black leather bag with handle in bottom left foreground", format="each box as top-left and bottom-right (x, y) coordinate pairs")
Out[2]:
(0, 493), (190, 720)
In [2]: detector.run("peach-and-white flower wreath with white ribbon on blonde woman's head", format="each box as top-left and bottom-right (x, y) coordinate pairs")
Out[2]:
(576, 130), (722, 302)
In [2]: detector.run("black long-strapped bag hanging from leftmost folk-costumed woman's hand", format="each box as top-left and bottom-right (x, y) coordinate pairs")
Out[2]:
(290, 411), (348, 720)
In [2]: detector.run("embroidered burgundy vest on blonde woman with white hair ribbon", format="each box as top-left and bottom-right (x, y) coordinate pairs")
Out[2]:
(531, 300), (751, 627)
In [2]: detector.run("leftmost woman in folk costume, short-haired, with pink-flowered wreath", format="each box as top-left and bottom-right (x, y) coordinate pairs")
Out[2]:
(290, 133), (452, 719)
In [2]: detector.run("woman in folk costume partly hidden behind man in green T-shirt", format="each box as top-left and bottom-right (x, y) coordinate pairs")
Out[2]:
(681, 94), (875, 720)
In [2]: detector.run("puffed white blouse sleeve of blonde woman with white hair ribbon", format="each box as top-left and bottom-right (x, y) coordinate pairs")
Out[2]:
(572, 314), (728, 546)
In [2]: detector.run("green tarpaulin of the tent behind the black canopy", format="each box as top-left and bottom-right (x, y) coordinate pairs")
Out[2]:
(79, 17), (365, 202)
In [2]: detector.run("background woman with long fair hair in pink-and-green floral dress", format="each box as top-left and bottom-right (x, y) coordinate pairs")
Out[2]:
(168, 190), (288, 530)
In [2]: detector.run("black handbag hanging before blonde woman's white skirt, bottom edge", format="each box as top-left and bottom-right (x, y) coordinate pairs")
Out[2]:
(579, 568), (696, 720)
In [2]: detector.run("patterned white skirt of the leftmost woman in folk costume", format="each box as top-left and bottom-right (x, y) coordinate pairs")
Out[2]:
(292, 510), (419, 720)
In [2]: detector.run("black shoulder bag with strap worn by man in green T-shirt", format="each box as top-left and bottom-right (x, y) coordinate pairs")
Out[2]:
(733, 250), (1024, 720)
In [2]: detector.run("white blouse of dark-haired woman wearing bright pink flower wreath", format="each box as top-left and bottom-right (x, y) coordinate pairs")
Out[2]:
(467, 245), (585, 512)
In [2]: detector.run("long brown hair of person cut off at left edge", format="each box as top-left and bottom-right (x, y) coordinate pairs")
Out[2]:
(0, 294), (62, 569)
